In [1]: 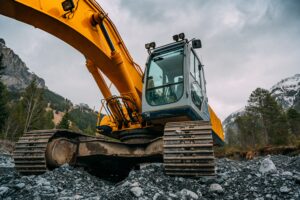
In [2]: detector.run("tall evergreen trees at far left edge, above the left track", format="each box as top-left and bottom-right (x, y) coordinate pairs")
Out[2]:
(1, 80), (54, 140)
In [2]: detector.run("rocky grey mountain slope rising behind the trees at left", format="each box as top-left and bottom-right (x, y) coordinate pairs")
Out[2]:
(0, 38), (97, 133)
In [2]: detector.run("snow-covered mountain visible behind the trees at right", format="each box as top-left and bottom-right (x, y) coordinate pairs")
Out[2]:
(223, 74), (300, 135)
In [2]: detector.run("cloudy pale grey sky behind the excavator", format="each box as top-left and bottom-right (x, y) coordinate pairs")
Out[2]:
(0, 0), (300, 120)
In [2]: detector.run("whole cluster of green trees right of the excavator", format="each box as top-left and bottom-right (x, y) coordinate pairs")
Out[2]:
(226, 88), (300, 149)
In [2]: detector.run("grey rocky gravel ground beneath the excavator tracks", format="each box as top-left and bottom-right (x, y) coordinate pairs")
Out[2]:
(0, 154), (300, 200)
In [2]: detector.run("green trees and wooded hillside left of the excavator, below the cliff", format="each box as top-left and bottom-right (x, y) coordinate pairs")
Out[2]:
(0, 76), (97, 140)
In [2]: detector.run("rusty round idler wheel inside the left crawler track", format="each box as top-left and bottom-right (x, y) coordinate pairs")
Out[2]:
(46, 138), (77, 168)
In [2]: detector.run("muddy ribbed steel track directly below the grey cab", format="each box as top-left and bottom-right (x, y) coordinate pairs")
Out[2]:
(163, 121), (215, 177)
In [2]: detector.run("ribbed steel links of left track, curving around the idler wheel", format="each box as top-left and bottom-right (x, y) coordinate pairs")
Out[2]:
(13, 130), (55, 175)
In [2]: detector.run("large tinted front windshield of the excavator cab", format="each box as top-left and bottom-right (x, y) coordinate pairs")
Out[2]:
(146, 47), (183, 106)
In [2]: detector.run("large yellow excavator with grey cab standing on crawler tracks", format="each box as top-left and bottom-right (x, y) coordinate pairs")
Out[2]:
(0, 0), (224, 177)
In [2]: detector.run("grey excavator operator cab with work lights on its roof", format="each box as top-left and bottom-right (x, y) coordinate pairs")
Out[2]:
(142, 35), (209, 124)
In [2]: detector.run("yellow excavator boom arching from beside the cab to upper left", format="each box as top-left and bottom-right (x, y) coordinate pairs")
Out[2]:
(0, 0), (143, 128)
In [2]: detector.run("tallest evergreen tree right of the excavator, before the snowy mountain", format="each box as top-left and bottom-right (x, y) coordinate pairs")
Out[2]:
(236, 88), (289, 148)
